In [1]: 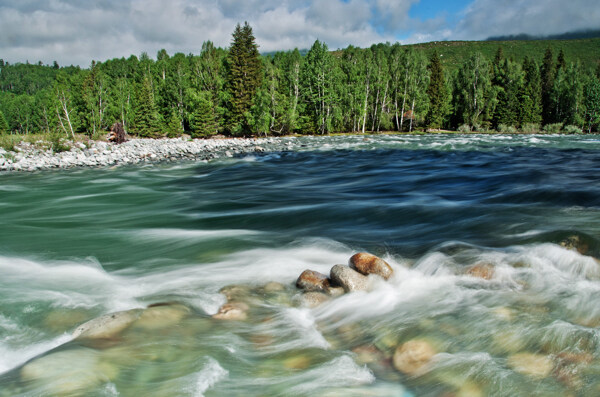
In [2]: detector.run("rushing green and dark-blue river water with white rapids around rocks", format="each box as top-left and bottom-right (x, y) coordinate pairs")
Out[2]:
(0, 135), (600, 396)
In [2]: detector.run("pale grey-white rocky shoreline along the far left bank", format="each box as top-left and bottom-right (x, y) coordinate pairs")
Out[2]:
(0, 138), (291, 172)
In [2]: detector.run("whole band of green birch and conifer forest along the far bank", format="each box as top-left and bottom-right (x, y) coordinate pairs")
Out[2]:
(0, 23), (600, 138)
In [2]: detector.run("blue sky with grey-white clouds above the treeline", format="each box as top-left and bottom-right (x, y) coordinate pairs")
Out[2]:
(0, 0), (600, 67)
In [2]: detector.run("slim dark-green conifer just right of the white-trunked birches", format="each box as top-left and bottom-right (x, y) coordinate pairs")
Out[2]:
(426, 51), (448, 128)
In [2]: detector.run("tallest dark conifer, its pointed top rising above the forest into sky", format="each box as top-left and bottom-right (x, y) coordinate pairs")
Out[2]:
(227, 22), (262, 134)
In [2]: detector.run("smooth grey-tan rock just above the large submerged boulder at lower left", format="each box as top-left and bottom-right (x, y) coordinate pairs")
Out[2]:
(73, 309), (144, 339)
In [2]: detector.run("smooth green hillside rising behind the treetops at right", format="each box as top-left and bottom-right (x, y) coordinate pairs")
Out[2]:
(412, 38), (600, 70)
